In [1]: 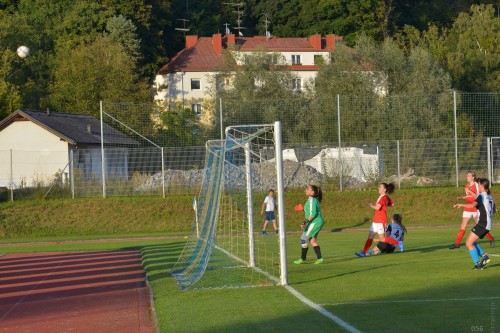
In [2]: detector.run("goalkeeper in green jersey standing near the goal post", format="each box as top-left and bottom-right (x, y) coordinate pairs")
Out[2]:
(294, 185), (324, 264)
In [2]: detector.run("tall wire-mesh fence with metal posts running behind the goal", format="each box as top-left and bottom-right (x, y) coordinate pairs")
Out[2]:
(0, 92), (500, 200)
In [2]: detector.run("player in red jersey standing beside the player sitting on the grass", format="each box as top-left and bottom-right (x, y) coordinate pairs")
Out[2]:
(355, 183), (394, 257)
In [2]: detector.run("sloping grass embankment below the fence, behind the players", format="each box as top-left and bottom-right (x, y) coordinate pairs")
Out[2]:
(0, 187), (500, 242)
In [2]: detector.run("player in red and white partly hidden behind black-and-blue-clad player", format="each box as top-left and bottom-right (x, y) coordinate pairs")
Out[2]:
(450, 171), (495, 249)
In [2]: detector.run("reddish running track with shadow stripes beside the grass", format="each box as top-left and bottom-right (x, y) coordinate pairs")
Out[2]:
(0, 251), (156, 333)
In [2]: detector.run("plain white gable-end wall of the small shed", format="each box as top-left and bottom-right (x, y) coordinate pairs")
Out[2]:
(0, 121), (69, 187)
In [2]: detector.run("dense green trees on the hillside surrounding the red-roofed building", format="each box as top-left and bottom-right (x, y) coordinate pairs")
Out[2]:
(0, 0), (500, 147)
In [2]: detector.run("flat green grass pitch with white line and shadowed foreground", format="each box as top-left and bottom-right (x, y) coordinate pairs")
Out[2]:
(0, 227), (500, 333)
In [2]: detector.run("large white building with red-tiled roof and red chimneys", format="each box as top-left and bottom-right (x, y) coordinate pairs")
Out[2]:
(155, 34), (343, 114)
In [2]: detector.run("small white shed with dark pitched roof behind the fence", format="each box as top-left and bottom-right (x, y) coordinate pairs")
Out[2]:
(0, 110), (139, 188)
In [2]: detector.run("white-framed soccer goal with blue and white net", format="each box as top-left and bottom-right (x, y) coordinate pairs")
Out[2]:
(171, 122), (288, 290)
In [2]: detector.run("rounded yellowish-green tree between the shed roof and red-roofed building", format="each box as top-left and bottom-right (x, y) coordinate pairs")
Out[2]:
(50, 37), (149, 118)
